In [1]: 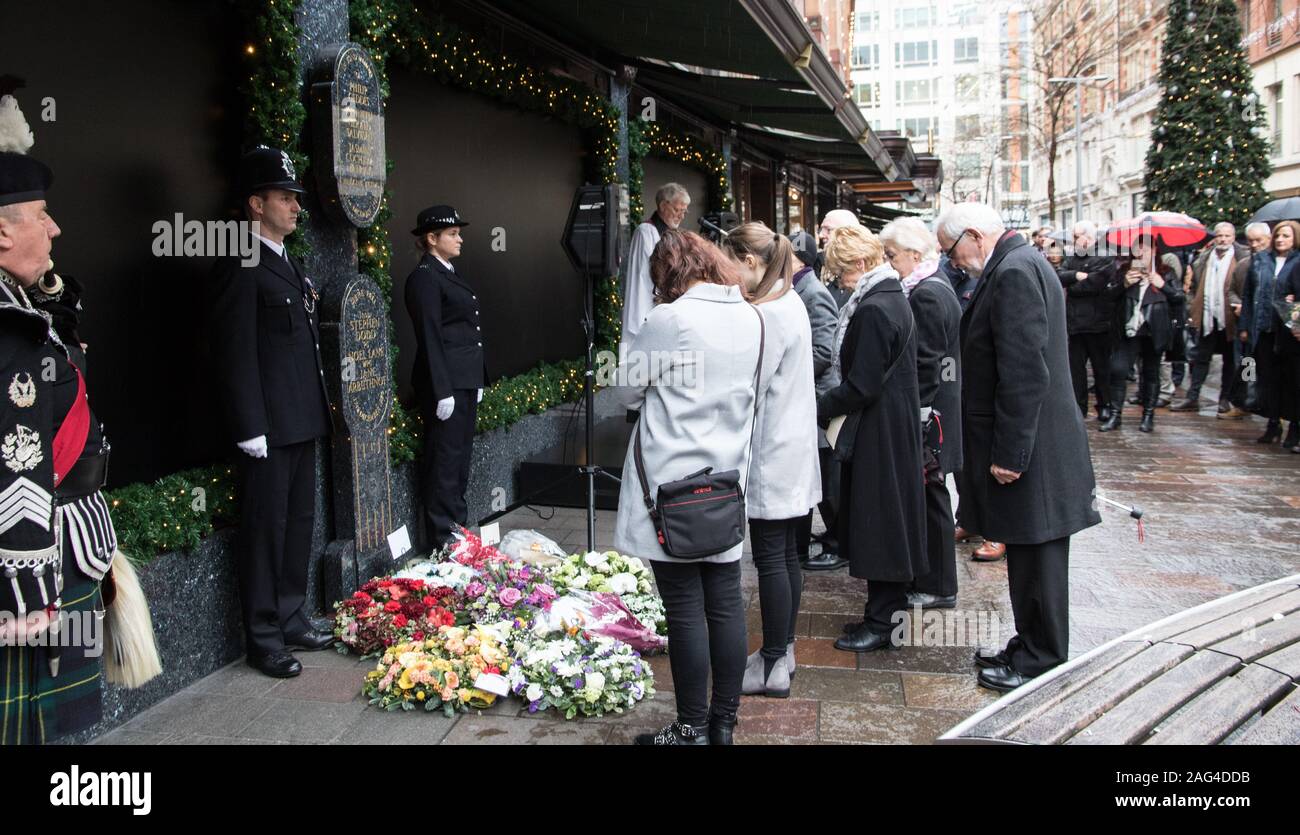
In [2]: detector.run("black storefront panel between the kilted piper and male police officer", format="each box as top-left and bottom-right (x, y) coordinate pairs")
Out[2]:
(0, 0), (242, 485)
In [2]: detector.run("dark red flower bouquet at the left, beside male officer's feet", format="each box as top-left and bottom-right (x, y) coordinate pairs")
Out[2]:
(334, 577), (456, 657)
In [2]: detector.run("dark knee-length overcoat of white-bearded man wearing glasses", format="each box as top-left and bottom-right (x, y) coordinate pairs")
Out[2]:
(958, 233), (1101, 545)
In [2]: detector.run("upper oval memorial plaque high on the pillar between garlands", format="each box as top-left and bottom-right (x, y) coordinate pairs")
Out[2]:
(312, 43), (386, 226)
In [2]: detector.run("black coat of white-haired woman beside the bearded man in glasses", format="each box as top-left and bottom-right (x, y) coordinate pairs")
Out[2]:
(907, 274), (962, 472)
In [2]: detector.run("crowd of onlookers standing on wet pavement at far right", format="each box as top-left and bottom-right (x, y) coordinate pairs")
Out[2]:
(1034, 220), (1300, 444)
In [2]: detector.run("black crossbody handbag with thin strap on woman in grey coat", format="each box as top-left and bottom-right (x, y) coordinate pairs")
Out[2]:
(634, 301), (767, 559)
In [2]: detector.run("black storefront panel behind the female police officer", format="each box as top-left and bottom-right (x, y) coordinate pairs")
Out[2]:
(386, 68), (584, 391)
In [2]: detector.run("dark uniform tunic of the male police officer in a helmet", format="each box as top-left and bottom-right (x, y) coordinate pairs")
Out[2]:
(211, 243), (333, 446)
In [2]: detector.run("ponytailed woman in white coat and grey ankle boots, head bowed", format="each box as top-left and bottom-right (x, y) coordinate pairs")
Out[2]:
(723, 222), (822, 698)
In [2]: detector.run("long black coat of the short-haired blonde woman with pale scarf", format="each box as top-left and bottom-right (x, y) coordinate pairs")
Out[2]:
(818, 278), (928, 583)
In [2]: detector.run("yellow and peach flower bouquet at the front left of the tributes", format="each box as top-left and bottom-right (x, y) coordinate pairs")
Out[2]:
(361, 626), (511, 717)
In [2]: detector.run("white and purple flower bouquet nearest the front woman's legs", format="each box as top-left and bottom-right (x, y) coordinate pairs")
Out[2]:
(506, 627), (654, 719)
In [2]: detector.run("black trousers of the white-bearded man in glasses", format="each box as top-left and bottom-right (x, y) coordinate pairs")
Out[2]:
(1006, 536), (1070, 675)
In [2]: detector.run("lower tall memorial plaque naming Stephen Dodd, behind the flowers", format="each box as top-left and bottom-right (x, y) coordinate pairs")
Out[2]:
(338, 277), (393, 557)
